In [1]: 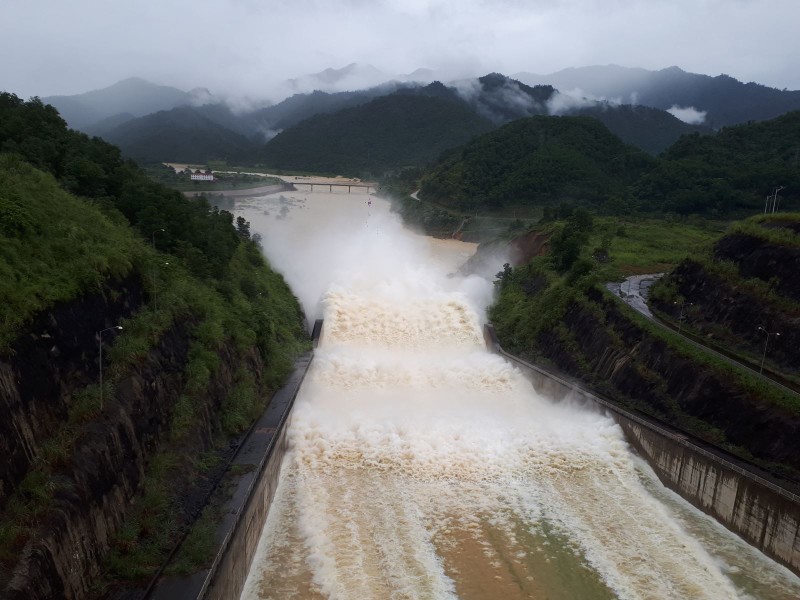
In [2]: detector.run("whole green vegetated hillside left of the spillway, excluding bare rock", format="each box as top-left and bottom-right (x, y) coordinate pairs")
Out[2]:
(0, 94), (307, 589)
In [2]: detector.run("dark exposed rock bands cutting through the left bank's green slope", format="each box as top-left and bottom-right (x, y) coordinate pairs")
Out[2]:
(0, 280), (268, 599)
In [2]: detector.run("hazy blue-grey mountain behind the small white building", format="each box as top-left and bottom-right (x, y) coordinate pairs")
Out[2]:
(102, 106), (257, 163)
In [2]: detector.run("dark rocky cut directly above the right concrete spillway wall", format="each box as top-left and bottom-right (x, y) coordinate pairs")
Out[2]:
(538, 290), (800, 481)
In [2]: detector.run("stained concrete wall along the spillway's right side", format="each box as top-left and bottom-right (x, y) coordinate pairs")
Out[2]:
(484, 325), (800, 575)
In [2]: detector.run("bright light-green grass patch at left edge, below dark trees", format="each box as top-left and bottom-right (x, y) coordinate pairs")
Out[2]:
(0, 154), (138, 352)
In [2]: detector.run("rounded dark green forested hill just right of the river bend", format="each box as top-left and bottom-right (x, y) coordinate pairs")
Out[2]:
(420, 116), (655, 209)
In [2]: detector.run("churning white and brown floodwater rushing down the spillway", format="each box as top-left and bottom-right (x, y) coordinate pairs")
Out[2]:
(234, 194), (800, 599)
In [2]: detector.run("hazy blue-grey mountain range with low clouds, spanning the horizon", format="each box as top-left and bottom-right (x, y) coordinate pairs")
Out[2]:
(36, 64), (800, 174)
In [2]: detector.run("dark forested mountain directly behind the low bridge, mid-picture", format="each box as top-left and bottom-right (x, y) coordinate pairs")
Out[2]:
(260, 93), (492, 176)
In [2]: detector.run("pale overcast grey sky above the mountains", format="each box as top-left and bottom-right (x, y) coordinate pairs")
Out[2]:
(0, 0), (800, 98)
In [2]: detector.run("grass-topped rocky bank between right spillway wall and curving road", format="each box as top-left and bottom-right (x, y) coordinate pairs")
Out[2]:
(490, 211), (800, 481)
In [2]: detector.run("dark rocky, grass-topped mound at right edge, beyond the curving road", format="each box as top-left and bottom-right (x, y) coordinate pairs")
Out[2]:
(651, 213), (800, 383)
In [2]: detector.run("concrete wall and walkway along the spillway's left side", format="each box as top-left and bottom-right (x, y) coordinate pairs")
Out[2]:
(147, 320), (322, 600)
